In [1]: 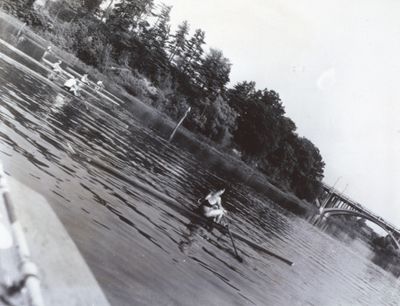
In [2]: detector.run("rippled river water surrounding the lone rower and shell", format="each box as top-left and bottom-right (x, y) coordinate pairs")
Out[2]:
(0, 52), (400, 306)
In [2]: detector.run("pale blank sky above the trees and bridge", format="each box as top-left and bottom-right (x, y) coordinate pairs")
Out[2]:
(162, 0), (400, 228)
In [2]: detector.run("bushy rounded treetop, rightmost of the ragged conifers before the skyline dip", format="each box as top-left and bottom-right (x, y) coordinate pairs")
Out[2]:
(198, 49), (232, 96)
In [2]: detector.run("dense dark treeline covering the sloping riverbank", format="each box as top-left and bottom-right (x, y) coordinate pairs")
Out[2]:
(3, 0), (324, 200)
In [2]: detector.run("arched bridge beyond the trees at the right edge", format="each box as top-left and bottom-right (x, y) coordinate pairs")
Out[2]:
(315, 184), (400, 250)
